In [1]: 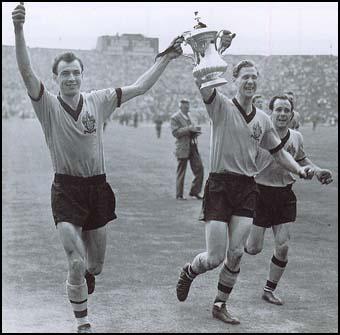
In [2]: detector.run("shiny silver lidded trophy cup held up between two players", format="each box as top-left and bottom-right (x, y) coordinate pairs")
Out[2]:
(182, 12), (232, 88)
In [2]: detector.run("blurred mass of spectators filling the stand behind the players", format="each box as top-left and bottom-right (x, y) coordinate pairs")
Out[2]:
(2, 46), (338, 123)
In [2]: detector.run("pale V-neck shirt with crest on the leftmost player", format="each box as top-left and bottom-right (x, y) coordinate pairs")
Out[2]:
(31, 84), (121, 177)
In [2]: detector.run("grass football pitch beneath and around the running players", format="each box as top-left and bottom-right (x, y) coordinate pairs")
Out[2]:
(2, 119), (338, 333)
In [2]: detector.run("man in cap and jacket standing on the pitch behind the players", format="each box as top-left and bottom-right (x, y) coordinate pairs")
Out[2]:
(171, 99), (204, 200)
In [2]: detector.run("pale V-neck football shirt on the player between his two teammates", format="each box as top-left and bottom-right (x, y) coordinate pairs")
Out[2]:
(205, 89), (281, 177)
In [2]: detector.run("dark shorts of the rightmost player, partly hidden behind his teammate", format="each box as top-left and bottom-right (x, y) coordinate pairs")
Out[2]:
(253, 184), (296, 228)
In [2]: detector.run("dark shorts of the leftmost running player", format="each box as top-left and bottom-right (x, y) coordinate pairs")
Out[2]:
(51, 174), (117, 230)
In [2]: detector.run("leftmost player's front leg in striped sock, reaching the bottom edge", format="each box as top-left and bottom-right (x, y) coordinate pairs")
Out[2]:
(57, 222), (90, 332)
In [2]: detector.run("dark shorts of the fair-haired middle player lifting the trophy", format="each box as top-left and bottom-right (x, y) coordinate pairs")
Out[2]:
(200, 172), (258, 223)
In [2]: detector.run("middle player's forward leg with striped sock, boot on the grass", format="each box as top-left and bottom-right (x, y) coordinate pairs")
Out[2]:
(213, 215), (253, 324)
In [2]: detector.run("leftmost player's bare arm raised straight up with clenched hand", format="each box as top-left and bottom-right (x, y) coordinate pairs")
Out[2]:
(12, 2), (40, 99)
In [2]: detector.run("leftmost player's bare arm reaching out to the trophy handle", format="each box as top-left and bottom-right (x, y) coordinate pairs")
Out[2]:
(121, 37), (183, 103)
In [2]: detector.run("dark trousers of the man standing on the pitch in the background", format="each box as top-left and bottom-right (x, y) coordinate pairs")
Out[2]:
(176, 144), (204, 197)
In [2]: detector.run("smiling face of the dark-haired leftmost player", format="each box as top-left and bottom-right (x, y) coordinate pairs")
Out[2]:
(54, 59), (83, 96)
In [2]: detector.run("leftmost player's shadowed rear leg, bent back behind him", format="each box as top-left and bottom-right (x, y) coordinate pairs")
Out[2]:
(82, 226), (106, 294)
